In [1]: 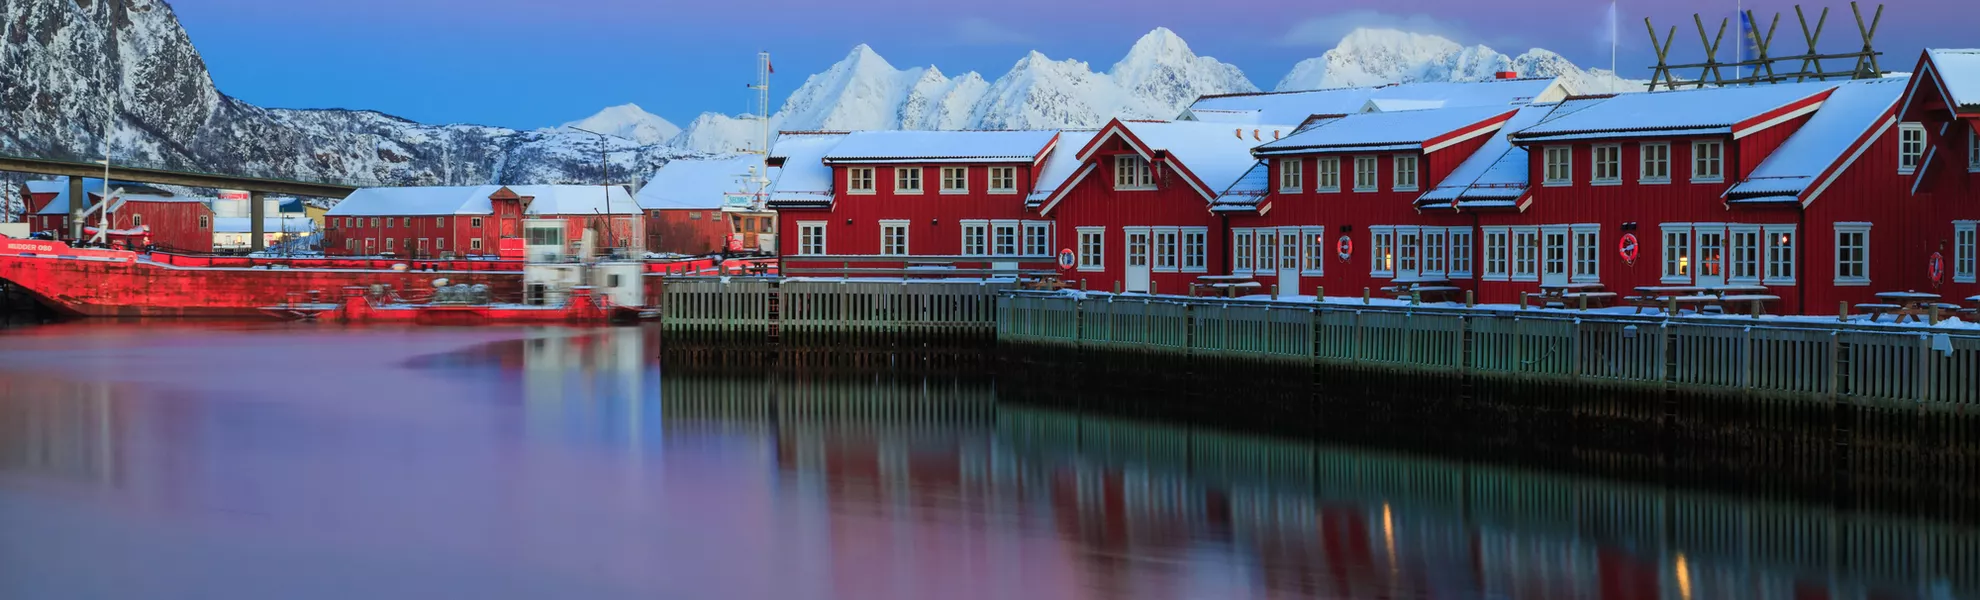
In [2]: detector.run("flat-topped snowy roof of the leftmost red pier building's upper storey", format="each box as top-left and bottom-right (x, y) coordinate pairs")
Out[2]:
(826, 131), (1059, 164)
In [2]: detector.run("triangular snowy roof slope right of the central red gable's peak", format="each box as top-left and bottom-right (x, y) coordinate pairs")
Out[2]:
(1123, 121), (1295, 194)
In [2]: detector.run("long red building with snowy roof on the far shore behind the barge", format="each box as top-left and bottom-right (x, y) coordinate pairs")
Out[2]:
(323, 186), (644, 257)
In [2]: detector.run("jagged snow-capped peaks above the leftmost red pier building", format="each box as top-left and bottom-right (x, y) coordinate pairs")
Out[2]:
(673, 28), (1257, 152)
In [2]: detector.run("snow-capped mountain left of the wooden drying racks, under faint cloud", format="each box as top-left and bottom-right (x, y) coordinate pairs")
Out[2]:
(1277, 30), (1643, 93)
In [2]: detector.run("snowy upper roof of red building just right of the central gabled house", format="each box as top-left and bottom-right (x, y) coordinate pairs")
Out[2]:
(1253, 107), (1517, 156)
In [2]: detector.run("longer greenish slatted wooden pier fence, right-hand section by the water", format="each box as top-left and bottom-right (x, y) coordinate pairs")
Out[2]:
(996, 291), (1980, 406)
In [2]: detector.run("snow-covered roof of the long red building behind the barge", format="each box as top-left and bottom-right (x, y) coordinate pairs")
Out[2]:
(327, 186), (640, 216)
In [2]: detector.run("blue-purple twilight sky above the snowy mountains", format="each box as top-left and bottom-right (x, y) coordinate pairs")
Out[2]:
(172, 0), (1980, 127)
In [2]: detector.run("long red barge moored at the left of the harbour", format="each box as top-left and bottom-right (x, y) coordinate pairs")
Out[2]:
(0, 238), (774, 325)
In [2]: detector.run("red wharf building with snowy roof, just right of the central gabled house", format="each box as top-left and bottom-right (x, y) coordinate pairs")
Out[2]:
(1216, 107), (1519, 295)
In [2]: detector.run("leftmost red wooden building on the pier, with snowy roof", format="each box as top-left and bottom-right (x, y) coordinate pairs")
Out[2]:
(768, 131), (1059, 275)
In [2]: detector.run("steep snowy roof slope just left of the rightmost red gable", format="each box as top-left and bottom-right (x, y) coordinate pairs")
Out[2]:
(1727, 79), (1907, 202)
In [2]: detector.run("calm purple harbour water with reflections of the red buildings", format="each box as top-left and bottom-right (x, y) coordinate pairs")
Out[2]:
(0, 325), (1980, 600)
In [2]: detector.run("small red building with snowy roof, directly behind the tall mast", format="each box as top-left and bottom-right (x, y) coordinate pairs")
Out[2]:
(638, 156), (776, 255)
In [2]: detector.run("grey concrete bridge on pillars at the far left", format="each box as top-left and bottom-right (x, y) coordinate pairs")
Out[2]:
(0, 156), (356, 251)
